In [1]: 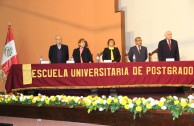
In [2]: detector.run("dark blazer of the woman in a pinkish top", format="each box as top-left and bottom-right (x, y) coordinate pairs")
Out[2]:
(73, 47), (93, 63)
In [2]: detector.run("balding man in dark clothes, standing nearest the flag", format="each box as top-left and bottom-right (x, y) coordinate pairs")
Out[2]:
(49, 36), (69, 63)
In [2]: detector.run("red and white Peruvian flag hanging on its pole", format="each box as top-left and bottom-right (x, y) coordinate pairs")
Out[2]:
(1, 25), (18, 76)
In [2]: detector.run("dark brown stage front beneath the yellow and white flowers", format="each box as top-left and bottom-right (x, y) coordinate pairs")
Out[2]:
(0, 94), (194, 126)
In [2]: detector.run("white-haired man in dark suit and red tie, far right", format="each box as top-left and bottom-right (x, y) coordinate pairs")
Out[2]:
(158, 31), (180, 61)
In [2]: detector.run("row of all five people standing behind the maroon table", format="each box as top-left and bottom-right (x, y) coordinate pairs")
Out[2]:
(49, 31), (180, 63)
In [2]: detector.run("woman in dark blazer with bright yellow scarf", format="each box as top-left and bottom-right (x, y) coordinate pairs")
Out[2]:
(102, 39), (121, 62)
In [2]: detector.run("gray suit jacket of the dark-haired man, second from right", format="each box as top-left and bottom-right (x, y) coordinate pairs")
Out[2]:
(128, 46), (148, 62)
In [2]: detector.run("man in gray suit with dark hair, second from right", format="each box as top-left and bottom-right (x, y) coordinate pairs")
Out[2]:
(128, 37), (148, 62)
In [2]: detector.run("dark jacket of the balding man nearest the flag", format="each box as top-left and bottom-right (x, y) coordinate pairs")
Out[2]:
(49, 44), (69, 63)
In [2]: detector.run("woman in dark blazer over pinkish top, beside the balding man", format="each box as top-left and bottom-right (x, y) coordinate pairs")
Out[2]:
(73, 39), (93, 63)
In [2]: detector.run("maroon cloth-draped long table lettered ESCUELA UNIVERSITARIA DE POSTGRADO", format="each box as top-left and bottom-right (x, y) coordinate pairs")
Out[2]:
(6, 61), (194, 93)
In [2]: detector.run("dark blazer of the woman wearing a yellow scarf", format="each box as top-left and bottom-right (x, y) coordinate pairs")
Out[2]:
(102, 47), (121, 62)
